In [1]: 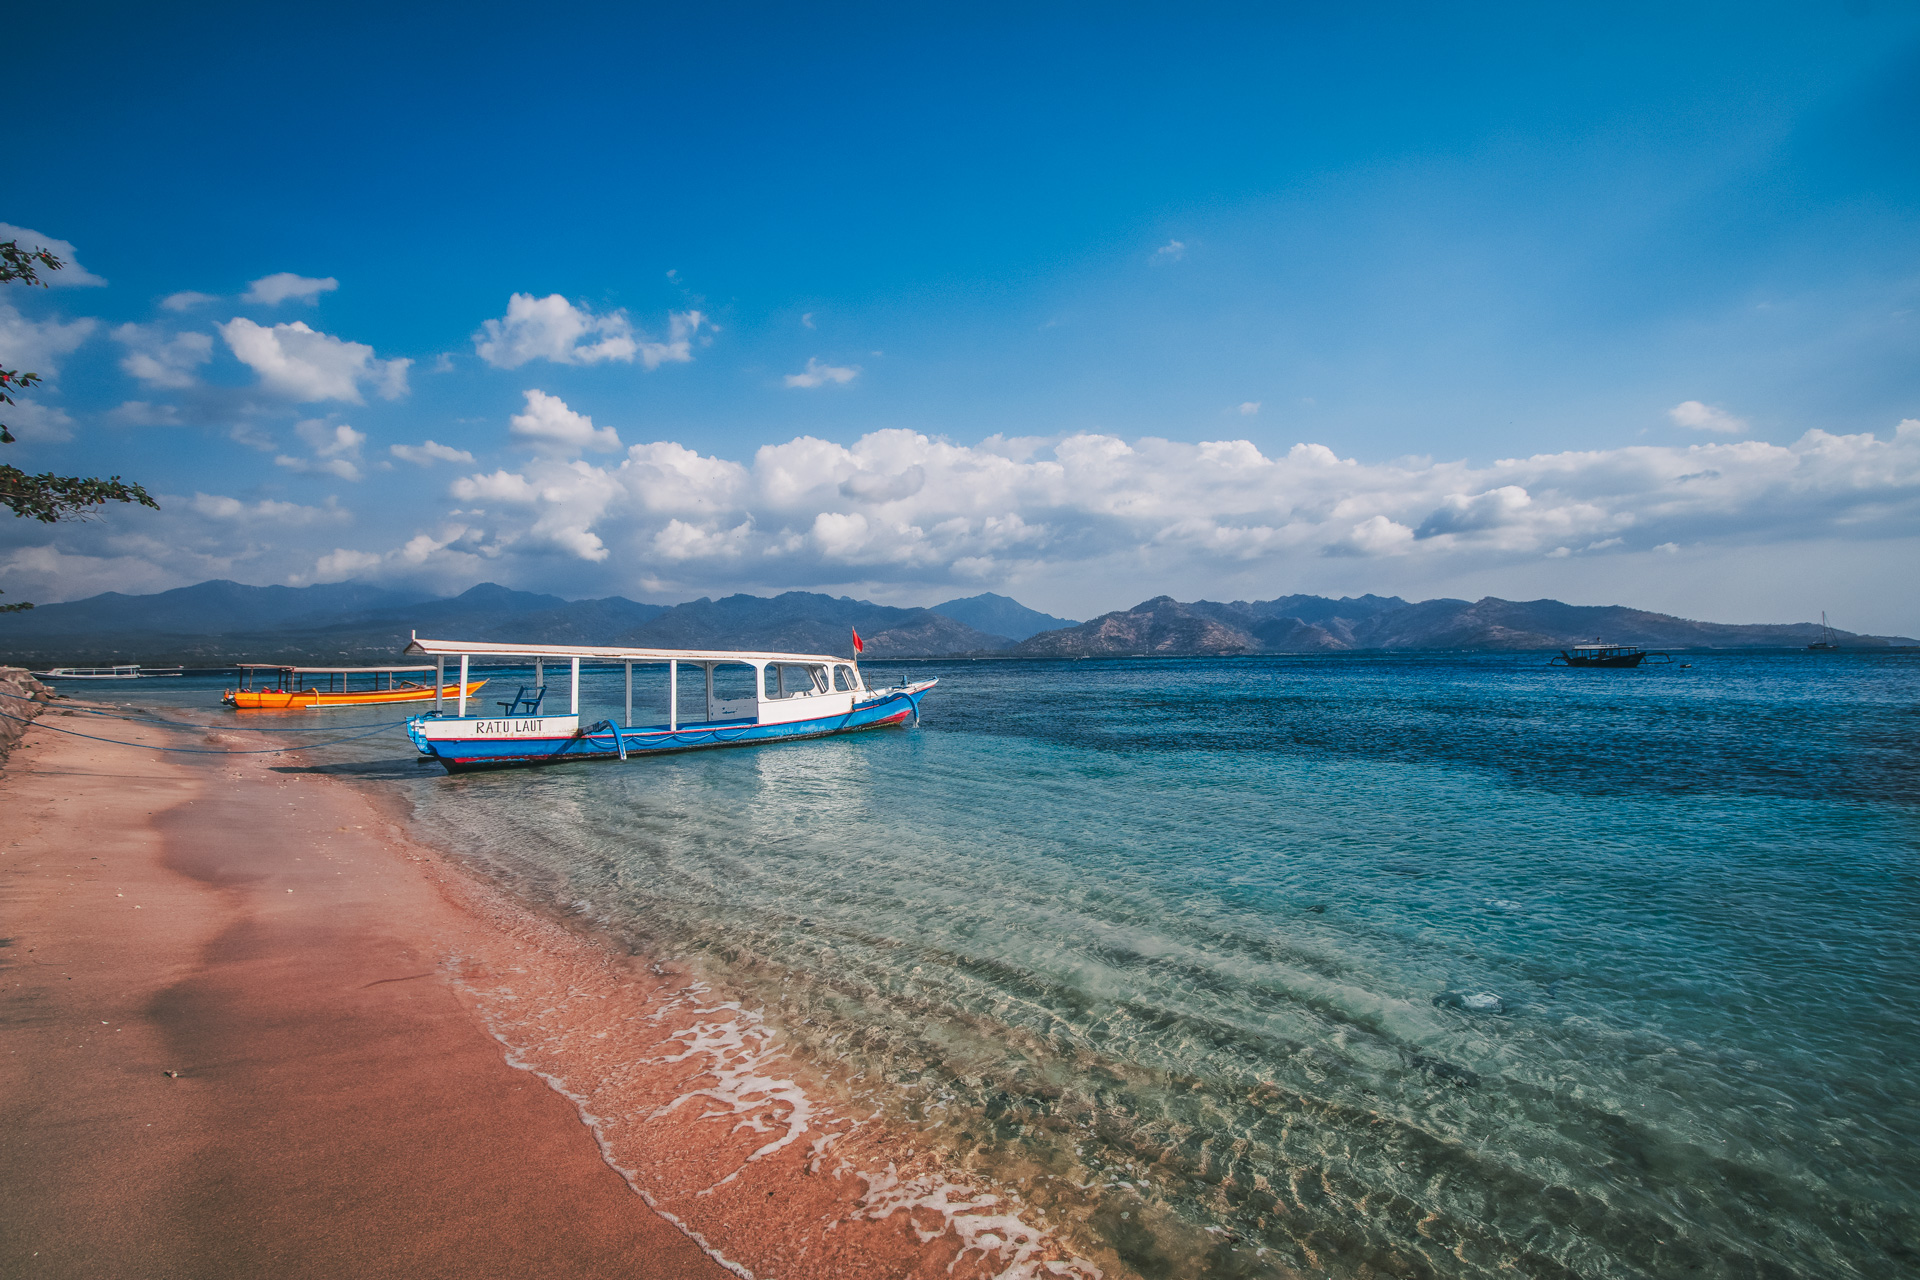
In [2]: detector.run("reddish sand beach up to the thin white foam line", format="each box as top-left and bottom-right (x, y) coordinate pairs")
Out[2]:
(0, 712), (728, 1280)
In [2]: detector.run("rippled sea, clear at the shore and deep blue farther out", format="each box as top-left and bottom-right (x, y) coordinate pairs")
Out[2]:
(123, 654), (1920, 1276)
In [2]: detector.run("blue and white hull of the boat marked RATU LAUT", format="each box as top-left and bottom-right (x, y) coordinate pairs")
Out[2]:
(407, 681), (937, 773)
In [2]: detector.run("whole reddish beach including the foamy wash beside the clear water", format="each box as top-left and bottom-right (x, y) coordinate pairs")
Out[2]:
(0, 702), (1102, 1280)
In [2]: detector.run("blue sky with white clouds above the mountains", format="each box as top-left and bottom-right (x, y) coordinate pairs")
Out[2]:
(0, 4), (1920, 633)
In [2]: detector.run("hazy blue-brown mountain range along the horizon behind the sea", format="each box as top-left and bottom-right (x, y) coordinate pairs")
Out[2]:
(0, 581), (1912, 666)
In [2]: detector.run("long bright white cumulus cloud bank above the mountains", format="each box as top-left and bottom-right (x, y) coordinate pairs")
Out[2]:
(345, 422), (1920, 591)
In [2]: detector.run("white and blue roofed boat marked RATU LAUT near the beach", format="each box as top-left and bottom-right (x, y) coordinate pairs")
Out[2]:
(407, 635), (939, 771)
